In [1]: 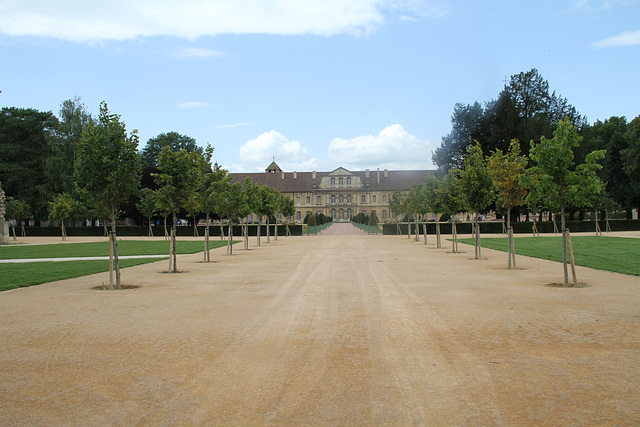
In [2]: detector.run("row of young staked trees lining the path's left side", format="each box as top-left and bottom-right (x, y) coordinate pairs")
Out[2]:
(0, 102), (295, 288)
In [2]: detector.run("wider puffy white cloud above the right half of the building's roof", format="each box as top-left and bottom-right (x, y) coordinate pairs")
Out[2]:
(328, 124), (435, 170)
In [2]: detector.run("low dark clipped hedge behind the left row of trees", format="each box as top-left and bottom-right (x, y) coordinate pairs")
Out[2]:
(23, 224), (302, 237)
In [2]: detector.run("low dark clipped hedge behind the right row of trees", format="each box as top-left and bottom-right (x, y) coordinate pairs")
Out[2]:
(382, 219), (640, 235)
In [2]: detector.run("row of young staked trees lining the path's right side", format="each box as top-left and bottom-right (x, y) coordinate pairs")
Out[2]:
(389, 117), (605, 286)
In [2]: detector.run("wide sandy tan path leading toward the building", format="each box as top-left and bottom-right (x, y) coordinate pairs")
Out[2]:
(0, 234), (640, 425)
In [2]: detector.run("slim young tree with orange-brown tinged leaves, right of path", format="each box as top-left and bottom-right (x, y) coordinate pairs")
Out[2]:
(488, 139), (528, 270)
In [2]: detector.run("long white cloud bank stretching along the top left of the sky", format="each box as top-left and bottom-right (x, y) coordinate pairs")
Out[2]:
(0, 0), (389, 42)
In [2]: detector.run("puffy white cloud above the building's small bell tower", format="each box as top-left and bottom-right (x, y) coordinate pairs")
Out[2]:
(236, 130), (318, 172)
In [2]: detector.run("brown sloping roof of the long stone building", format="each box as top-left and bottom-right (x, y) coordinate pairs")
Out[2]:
(231, 167), (436, 193)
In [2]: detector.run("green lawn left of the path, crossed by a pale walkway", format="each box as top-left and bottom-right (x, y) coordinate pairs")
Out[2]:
(0, 239), (227, 291)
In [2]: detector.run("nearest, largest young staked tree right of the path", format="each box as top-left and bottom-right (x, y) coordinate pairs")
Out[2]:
(527, 119), (605, 286)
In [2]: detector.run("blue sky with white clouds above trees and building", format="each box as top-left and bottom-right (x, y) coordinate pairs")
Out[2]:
(0, 0), (640, 172)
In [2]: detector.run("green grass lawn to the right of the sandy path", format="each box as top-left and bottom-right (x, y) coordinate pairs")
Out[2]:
(460, 236), (640, 276)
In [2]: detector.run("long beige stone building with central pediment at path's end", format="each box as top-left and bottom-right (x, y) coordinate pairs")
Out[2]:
(232, 161), (435, 222)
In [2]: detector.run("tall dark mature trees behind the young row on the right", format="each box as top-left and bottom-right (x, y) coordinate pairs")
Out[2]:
(432, 69), (640, 218)
